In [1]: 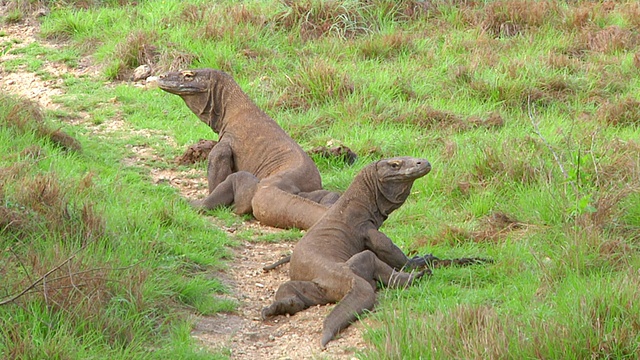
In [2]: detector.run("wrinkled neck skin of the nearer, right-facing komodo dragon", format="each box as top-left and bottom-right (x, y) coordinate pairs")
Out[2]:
(343, 166), (413, 228)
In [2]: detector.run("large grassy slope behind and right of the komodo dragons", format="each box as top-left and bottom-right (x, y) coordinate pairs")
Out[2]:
(1, 0), (640, 358)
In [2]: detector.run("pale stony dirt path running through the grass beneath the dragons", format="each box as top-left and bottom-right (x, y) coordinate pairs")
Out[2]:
(0, 10), (366, 359)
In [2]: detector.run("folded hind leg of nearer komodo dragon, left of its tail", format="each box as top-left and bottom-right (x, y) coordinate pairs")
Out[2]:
(262, 281), (329, 320)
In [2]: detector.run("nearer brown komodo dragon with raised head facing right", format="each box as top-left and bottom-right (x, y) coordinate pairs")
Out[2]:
(262, 157), (431, 347)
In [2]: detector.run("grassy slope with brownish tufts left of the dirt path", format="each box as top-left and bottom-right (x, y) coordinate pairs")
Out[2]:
(0, 95), (234, 359)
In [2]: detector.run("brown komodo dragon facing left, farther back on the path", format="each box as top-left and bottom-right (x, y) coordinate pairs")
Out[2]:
(157, 69), (339, 229)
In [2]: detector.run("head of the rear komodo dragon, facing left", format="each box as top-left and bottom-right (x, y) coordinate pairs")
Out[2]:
(157, 69), (245, 133)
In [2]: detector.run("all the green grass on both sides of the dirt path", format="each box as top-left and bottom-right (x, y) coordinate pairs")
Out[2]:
(0, 0), (640, 359)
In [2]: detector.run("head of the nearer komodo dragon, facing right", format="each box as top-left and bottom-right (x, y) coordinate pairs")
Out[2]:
(370, 156), (431, 219)
